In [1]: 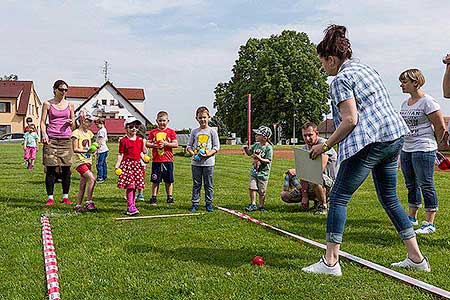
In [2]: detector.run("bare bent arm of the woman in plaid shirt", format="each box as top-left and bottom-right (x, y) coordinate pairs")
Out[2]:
(310, 98), (358, 159)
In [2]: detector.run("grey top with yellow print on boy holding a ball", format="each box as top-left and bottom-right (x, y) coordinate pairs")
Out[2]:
(187, 127), (220, 167)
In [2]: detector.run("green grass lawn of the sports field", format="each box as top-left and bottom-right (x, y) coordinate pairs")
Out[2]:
(0, 144), (450, 299)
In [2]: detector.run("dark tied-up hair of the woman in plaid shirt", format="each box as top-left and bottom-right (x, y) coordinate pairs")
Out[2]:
(317, 24), (352, 59)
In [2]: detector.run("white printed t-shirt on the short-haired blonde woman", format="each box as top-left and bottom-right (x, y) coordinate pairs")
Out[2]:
(400, 95), (441, 152)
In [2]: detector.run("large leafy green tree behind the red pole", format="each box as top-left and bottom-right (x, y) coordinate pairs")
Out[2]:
(214, 30), (329, 137)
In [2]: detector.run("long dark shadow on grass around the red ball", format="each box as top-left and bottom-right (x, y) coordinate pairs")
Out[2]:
(124, 244), (300, 269)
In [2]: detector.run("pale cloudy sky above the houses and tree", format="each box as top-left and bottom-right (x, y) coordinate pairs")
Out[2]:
(0, 0), (450, 129)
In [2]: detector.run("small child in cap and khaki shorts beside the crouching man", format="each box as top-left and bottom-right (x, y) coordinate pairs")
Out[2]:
(242, 126), (273, 212)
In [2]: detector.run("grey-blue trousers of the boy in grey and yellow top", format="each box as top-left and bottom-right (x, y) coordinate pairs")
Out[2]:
(191, 166), (214, 205)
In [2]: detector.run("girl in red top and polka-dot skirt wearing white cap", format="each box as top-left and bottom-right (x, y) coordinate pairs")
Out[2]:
(115, 117), (147, 216)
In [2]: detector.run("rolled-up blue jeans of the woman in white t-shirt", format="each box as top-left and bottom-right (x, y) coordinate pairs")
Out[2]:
(400, 151), (438, 211)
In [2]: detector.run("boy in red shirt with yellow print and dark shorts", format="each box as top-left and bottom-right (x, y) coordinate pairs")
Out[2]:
(147, 111), (178, 205)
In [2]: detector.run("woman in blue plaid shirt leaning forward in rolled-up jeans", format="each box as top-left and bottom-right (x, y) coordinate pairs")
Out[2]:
(302, 25), (431, 276)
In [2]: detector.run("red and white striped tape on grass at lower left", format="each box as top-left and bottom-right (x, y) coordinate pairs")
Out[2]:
(41, 216), (61, 300)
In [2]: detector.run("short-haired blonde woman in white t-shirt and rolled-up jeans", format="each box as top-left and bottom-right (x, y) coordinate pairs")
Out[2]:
(399, 69), (445, 234)
